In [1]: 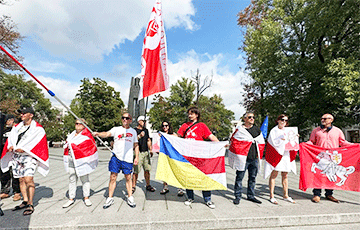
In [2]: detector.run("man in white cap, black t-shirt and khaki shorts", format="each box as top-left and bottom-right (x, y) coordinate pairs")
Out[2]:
(132, 116), (155, 192)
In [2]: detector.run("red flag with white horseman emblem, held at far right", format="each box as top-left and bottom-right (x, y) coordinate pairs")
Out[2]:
(299, 143), (360, 192)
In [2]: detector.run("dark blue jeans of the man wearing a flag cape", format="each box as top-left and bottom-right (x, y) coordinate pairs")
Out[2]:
(234, 159), (259, 199)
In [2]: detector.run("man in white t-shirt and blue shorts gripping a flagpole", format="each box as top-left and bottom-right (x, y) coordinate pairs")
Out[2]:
(93, 113), (139, 209)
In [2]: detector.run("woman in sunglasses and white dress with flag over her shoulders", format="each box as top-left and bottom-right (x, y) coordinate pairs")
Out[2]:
(264, 114), (297, 204)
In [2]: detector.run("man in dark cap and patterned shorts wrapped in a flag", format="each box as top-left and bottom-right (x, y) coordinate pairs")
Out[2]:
(1, 107), (49, 215)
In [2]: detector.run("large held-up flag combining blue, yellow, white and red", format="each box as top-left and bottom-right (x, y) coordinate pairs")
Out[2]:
(155, 133), (227, 190)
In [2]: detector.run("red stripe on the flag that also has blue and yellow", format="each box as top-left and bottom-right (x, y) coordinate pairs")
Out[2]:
(184, 156), (225, 174)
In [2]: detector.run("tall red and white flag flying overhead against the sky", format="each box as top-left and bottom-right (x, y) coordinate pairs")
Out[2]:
(139, 0), (169, 100)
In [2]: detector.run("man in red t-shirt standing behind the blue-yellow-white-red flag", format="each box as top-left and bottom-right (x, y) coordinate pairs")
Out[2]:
(177, 107), (219, 208)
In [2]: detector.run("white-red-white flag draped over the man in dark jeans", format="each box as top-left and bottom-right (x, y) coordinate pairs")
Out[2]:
(229, 126), (265, 171)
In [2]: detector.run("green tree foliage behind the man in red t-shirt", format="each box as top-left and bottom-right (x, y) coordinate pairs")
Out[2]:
(149, 78), (234, 139)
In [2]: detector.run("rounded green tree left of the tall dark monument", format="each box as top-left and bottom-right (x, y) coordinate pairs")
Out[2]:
(64, 78), (124, 132)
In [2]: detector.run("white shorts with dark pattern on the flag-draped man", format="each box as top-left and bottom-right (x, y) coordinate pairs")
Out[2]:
(12, 153), (38, 178)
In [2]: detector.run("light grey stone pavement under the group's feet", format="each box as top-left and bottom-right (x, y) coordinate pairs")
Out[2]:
(0, 148), (360, 229)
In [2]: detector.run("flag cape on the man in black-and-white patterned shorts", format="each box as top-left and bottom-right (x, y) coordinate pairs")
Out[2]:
(1, 121), (49, 176)
